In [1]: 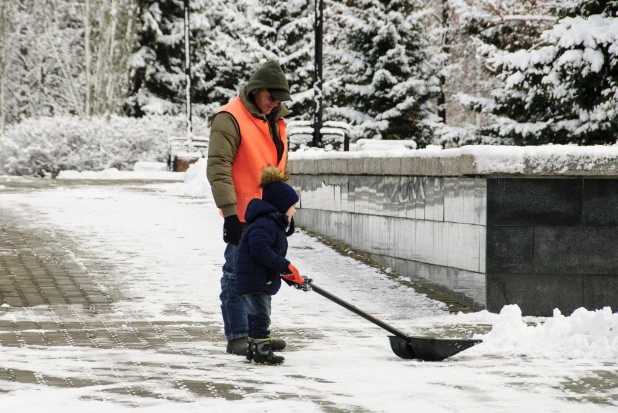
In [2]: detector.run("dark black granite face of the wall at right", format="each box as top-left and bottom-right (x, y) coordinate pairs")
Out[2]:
(486, 177), (618, 316)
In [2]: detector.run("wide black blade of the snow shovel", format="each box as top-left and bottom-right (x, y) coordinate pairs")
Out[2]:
(388, 336), (482, 361)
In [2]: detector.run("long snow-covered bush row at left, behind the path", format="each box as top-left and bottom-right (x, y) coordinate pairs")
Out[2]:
(0, 116), (204, 177)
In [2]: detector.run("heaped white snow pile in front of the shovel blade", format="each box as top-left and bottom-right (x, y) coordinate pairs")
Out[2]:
(458, 305), (618, 359)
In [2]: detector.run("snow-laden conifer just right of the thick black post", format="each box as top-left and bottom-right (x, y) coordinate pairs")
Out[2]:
(325, 0), (440, 147)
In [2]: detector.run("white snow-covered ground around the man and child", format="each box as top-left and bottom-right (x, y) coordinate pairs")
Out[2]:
(0, 163), (618, 413)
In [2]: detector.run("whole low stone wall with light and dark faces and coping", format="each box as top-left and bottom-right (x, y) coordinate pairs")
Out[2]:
(291, 151), (618, 316)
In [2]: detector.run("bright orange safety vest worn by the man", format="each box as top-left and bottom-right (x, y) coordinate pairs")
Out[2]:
(219, 97), (288, 222)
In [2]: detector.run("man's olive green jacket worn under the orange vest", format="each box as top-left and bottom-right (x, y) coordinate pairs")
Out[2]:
(206, 86), (289, 217)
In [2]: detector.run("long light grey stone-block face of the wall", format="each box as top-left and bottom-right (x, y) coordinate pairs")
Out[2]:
(292, 174), (487, 309)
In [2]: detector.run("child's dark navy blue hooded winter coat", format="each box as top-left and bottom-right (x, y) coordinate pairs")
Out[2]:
(236, 198), (290, 295)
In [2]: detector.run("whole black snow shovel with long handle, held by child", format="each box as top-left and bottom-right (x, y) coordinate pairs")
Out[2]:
(297, 277), (482, 361)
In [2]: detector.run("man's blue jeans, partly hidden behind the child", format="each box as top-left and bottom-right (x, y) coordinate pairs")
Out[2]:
(219, 240), (249, 340)
